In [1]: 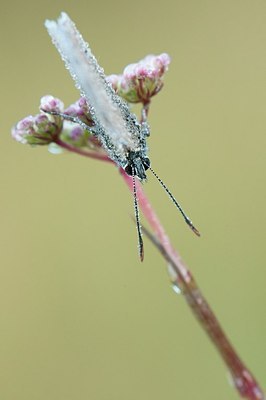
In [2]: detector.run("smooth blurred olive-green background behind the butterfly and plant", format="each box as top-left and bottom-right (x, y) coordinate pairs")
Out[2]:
(0, 0), (266, 400)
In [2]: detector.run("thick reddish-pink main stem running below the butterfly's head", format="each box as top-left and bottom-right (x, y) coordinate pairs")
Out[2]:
(120, 169), (265, 400)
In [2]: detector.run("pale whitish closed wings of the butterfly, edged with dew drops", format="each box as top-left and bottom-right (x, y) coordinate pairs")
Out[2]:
(45, 13), (140, 158)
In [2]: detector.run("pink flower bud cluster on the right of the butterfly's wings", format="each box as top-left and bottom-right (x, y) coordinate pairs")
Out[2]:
(107, 53), (171, 104)
